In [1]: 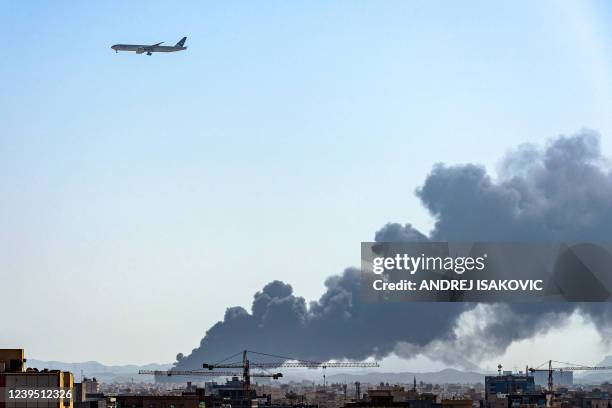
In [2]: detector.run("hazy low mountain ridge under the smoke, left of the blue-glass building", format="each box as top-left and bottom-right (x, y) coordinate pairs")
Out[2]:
(327, 368), (485, 384)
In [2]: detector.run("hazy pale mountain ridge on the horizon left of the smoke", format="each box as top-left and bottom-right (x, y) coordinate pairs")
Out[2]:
(26, 359), (172, 382)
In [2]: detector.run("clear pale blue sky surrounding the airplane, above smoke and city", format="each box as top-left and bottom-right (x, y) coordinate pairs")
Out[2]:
(0, 0), (612, 363)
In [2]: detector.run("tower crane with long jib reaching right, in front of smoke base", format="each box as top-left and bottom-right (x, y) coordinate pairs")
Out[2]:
(202, 350), (379, 392)
